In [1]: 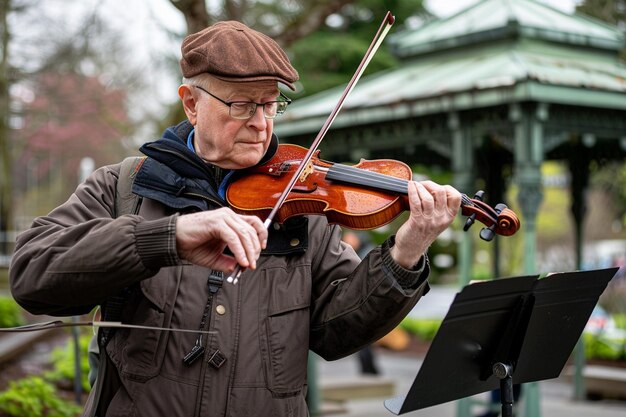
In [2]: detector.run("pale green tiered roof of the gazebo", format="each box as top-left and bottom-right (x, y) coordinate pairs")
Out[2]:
(276, 0), (626, 137)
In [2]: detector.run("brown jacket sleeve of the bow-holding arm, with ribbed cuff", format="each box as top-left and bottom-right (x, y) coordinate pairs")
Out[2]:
(9, 164), (178, 316)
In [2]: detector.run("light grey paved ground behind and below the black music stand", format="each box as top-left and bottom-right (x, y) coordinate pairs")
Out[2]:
(315, 287), (626, 417)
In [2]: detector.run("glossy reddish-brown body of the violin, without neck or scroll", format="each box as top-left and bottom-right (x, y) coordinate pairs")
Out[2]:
(226, 144), (413, 230)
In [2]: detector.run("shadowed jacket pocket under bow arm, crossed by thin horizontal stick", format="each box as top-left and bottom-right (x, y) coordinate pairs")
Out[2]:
(110, 268), (180, 382)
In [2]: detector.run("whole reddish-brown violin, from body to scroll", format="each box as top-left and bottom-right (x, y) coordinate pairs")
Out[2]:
(226, 144), (520, 241)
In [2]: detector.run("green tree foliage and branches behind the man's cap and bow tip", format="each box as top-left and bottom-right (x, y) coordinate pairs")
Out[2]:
(166, 0), (430, 98)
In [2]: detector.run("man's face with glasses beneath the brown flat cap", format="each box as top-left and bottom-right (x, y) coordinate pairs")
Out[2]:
(179, 78), (279, 169)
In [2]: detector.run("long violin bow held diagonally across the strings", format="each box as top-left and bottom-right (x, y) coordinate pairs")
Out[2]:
(226, 11), (396, 284)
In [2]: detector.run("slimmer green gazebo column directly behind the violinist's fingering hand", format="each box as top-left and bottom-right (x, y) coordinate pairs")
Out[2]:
(448, 112), (474, 286)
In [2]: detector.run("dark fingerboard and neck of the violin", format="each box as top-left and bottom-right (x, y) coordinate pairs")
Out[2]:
(326, 164), (474, 206)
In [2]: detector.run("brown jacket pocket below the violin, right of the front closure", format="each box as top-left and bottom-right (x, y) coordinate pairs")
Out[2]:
(259, 266), (310, 397)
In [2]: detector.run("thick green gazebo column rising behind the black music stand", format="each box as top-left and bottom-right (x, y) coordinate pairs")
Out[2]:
(509, 103), (548, 417)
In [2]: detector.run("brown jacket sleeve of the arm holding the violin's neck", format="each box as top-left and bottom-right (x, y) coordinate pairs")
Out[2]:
(310, 216), (430, 360)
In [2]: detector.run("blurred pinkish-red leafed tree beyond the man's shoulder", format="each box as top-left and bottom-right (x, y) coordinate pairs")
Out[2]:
(14, 72), (132, 210)
